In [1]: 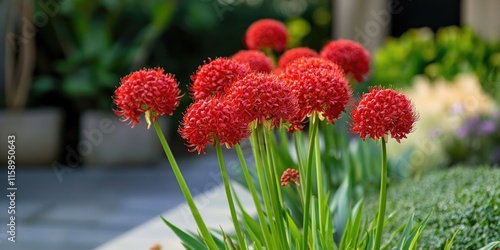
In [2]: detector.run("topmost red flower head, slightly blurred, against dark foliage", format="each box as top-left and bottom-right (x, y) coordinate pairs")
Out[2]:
(245, 19), (288, 52)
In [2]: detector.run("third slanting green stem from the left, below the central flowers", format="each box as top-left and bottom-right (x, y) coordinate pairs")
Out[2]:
(235, 145), (273, 249)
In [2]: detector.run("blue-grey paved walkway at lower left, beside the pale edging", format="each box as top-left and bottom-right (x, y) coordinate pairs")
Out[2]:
(0, 147), (250, 250)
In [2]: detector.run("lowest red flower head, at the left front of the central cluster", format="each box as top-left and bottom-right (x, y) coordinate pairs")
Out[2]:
(179, 96), (250, 154)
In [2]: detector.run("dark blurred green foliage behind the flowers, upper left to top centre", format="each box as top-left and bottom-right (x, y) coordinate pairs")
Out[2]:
(27, 0), (331, 111)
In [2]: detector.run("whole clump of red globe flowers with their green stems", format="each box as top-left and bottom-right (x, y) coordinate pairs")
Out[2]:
(114, 19), (417, 249)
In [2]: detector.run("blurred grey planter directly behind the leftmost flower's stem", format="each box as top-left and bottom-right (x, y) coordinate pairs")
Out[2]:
(77, 111), (167, 167)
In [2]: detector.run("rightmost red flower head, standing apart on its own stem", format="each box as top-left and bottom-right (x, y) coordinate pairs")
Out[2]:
(351, 88), (418, 142)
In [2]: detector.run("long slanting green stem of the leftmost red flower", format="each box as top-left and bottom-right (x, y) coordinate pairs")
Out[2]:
(153, 121), (217, 250)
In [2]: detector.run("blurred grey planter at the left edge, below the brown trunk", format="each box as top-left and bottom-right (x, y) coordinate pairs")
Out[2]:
(0, 108), (63, 165)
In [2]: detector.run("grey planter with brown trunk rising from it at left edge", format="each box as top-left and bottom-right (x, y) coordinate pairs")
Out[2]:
(0, 1), (63, 165)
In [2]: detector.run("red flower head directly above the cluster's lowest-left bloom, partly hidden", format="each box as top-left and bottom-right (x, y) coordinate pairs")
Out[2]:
(189, 58), (252, 100)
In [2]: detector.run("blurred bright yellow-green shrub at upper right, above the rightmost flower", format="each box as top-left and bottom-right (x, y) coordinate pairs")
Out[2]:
(374, 26), (500, 97)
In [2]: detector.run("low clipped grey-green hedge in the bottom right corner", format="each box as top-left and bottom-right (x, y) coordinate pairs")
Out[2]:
(366, 167), (500, 249)
